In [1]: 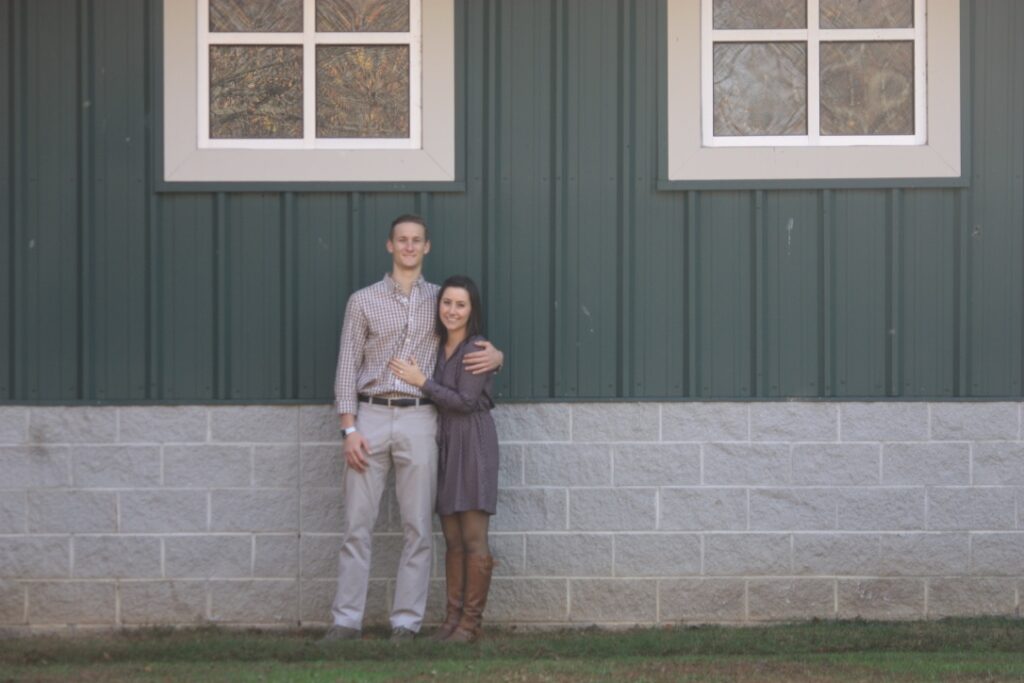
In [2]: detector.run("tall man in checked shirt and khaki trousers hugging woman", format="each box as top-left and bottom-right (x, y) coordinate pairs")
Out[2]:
(324, 215), (503, 641)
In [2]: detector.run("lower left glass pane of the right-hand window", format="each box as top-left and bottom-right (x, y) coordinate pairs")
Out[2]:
(715, 43), (807, 136)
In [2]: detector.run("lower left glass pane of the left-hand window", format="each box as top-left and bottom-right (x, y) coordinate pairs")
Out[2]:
(210, 45), (302, 138)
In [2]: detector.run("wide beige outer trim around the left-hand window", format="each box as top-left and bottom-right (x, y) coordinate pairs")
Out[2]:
(160, 0), (454, 184)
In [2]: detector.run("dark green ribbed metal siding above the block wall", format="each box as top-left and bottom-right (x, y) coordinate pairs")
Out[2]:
(0, 0), (1024, 402)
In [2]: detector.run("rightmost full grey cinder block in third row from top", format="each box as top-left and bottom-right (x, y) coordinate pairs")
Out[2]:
(928, 487), (1017, 531)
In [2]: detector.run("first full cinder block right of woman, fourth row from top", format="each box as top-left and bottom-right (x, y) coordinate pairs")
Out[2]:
(526, 533), (612, 577)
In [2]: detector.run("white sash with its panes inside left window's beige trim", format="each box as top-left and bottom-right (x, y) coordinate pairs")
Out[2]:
(197, 0), (422, 150)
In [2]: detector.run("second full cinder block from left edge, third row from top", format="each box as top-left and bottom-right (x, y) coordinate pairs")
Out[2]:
(119, 490), (207, 533)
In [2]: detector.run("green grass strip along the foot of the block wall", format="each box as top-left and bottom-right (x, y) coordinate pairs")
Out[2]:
(0, 618), (1024, 683)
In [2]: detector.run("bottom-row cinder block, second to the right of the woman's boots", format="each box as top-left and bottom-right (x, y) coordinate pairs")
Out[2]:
(569, 579), (657, 624)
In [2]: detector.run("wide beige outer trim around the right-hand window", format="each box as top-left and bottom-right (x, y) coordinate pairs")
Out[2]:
(659, 0), (964, 184)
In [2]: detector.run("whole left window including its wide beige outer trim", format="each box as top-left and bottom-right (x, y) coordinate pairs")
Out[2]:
(162, 0), (458, 188)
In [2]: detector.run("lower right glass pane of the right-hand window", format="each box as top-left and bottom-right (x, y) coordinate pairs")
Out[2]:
(821, 41), (913, 135)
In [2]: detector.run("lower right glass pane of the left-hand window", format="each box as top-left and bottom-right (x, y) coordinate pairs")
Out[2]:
(316, 45), (409, 137)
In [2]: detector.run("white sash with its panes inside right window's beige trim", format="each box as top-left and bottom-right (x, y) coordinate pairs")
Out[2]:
(700, 0), (928, 147)
